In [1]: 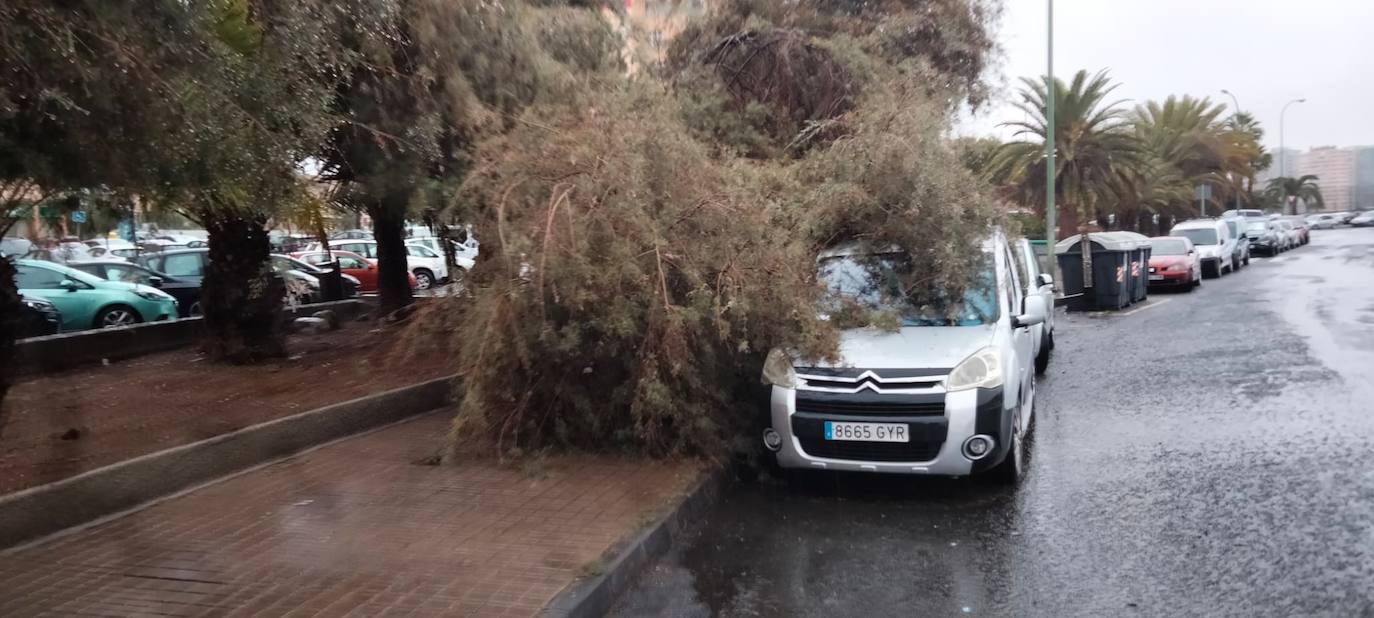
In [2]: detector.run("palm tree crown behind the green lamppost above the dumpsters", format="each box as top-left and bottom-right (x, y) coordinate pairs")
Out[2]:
(992, 71), (1145, 235)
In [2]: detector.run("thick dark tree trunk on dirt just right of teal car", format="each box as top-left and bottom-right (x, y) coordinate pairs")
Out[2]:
(201, 216), (286, 364)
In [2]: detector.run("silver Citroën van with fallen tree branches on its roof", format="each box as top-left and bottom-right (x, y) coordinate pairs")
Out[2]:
(763, 233), (1050, 482)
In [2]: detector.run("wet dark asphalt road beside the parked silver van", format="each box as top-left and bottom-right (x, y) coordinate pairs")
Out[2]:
(616, 228), (1374, 618)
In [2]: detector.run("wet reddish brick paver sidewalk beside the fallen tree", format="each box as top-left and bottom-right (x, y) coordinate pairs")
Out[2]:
(0, 415), (698, 618)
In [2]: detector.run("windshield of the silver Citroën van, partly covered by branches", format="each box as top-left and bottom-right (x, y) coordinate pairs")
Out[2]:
(818, 253), (998, 327)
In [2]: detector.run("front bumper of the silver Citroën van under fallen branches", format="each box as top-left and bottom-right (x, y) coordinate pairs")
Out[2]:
(769, 386), (1011, 477)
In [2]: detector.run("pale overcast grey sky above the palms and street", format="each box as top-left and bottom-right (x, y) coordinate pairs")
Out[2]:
(958, 0), (1374, 150)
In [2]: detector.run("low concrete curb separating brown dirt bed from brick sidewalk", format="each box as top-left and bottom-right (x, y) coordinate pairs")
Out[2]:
(0, 376), (458, 548)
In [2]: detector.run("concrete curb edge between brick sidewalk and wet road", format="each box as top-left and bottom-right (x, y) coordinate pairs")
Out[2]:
(539, 467), (730, 618)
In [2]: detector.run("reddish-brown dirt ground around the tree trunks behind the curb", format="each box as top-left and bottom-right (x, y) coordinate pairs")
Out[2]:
(0, 323), (453, 494)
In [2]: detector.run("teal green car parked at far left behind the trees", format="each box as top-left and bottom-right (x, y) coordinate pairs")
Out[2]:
(14, 260), (176, 331)
